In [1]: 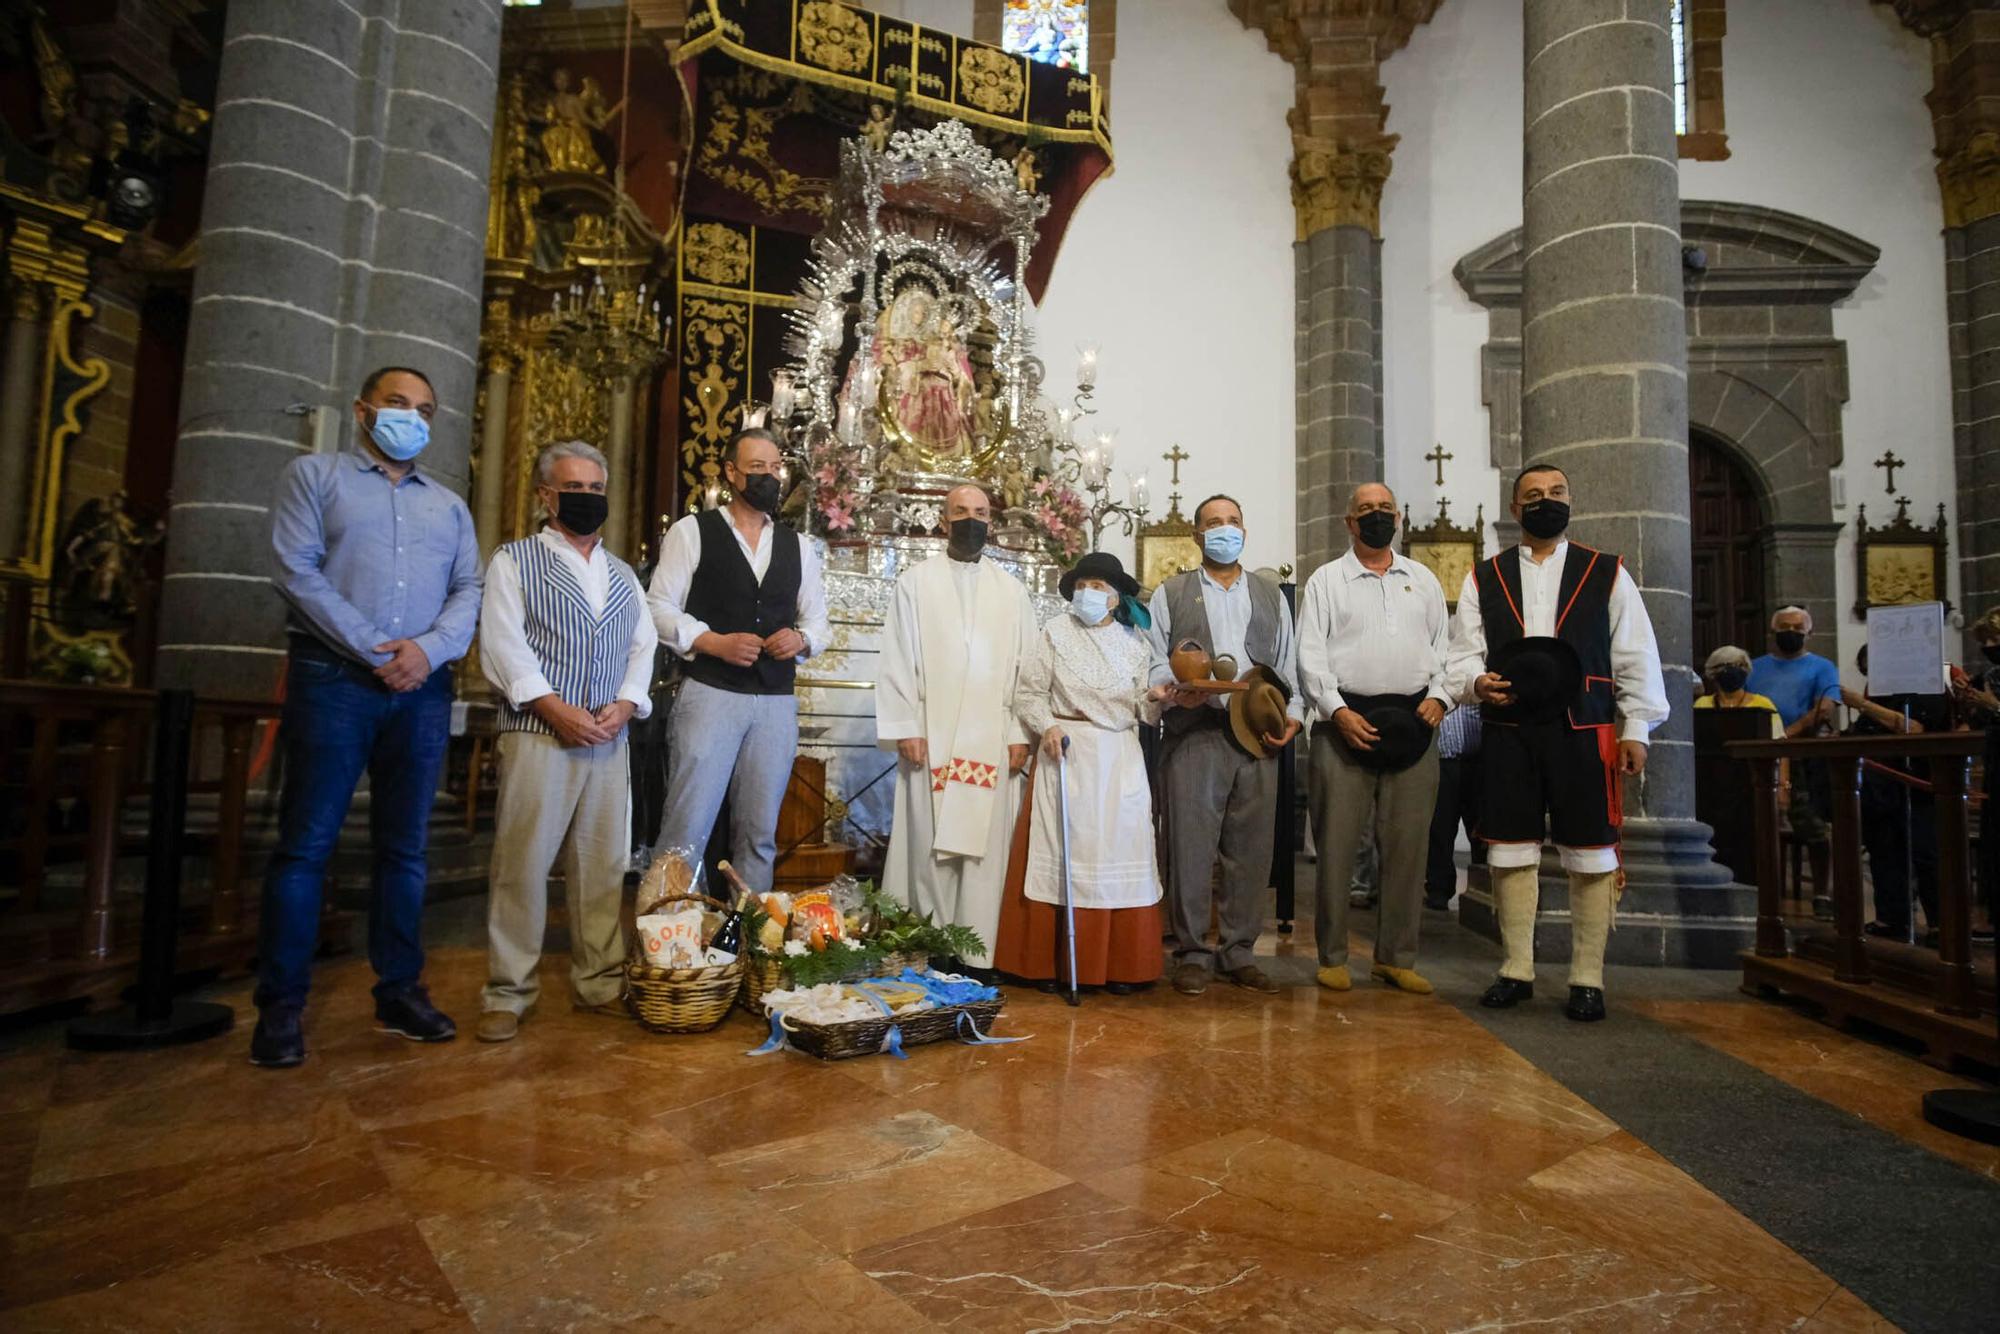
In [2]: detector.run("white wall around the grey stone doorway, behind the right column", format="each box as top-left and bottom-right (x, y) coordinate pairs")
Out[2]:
(1392, 0), (1956, 682)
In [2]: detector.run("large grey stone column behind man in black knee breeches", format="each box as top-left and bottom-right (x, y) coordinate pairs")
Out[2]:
(1520, 0), (1746, 962)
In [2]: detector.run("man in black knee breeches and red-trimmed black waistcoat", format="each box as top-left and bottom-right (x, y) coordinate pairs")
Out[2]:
(1450, 464), (1668, 1022)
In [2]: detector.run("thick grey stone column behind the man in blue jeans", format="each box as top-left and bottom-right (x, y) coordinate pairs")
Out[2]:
(158, 0), (500, 696)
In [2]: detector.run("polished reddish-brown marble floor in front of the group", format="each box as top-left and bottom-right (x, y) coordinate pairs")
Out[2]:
(0, 876), (2000, 1332)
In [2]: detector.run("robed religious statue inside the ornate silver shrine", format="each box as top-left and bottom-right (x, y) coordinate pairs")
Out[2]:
(874, 278), (978, 462)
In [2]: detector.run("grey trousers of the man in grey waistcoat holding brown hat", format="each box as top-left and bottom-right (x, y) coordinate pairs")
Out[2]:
(1162, 728), (1280, 972)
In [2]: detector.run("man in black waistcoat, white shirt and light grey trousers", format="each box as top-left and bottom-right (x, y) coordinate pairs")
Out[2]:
(646, 428), (832, 890)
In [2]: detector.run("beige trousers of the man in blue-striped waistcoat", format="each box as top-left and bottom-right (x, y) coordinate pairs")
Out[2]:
(482, 732), (632, 1014)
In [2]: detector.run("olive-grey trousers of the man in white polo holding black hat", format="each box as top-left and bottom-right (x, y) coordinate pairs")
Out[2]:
(1310, 728), (1438, 968)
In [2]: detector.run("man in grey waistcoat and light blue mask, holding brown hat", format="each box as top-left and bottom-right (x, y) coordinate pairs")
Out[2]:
(1148, 496), (1306, 996)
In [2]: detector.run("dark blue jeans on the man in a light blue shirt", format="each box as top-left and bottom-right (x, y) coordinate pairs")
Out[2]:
(256, 638), (452, 1008)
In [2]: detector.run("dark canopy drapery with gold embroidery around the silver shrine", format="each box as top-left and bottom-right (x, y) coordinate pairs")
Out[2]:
(670, 0), (1110, 512)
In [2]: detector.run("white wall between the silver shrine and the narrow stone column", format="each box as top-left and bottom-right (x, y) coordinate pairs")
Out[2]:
(1036, 0), (1298, 566)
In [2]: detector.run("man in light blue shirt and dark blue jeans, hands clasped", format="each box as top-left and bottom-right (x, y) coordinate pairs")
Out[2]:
(250, 366), (482, 1066)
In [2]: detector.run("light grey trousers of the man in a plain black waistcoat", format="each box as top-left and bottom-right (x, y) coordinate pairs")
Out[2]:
(656, 680), (798, 898)
